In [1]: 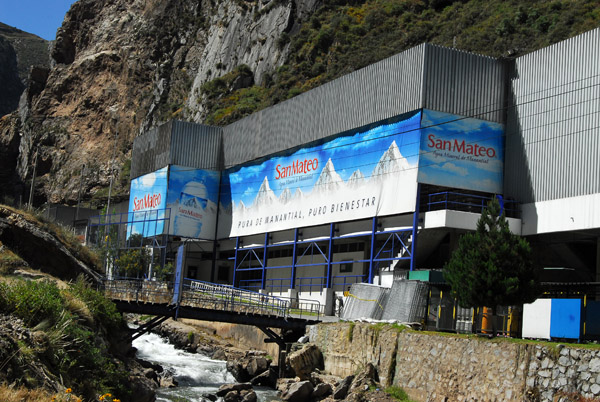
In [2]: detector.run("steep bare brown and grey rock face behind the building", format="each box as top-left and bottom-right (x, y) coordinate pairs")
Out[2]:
(0, 0), (316, 204)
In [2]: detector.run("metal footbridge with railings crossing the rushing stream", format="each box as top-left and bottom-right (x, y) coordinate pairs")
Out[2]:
(102, 278), (322, 345)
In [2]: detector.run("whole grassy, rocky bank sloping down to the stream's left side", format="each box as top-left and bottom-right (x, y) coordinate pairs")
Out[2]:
(0, 206), (158, 402)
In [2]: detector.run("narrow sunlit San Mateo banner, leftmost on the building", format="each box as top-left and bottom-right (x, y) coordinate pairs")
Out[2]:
(127, 167), (168, 238)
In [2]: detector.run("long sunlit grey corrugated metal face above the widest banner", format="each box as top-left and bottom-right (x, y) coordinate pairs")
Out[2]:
(223, 45), (426, 167)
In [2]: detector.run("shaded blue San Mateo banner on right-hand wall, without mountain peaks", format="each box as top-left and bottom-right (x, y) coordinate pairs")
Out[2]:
(418, 109), (504, 194)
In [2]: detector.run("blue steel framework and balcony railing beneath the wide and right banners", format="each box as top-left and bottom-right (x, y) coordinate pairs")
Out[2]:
(232, 188), (519, 292)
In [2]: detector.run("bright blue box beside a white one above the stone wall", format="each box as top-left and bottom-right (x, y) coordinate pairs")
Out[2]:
(550, 299), (583, 340)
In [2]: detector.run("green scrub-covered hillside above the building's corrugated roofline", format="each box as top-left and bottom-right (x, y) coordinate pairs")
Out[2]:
(203, 0), (600, 125)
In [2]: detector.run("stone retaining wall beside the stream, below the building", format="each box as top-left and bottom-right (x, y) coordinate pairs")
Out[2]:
(309, 323), (600, 402)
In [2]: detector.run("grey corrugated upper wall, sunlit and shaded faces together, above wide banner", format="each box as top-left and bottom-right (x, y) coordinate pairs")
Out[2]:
(223, 44), (505, 167)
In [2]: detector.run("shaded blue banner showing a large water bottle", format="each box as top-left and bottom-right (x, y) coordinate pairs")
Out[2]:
(167, 165), (220, 239)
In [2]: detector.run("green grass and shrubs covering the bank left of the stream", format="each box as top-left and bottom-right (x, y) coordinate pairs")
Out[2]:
(0, 279), (128, 398)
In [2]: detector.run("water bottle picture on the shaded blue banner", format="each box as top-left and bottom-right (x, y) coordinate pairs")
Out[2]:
(174, 181), (208, 237)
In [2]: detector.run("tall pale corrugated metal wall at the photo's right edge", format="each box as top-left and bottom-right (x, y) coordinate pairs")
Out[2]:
(504, 29), (600, 203)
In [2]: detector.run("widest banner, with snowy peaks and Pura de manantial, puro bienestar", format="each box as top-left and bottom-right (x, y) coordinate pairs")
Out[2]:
(229, 111), (421, 237)
